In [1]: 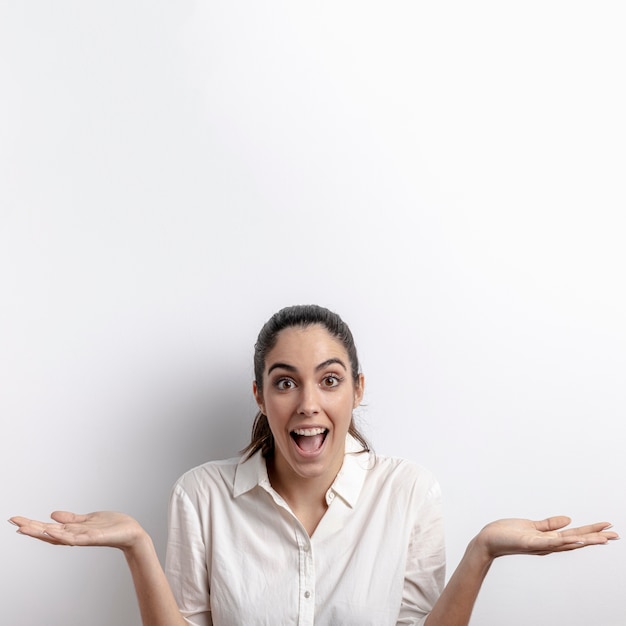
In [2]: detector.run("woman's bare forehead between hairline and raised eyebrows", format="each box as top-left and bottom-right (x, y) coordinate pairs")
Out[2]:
(265, 324), (349, 370)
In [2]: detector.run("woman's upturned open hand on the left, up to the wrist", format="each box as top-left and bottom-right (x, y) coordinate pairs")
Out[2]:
(9, 511), (146, 551)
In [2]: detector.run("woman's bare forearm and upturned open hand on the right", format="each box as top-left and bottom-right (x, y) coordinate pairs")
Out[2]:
(426, 516), (618, 626)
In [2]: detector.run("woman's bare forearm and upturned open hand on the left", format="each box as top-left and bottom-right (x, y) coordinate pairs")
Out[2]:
(9, 511), (187, 626)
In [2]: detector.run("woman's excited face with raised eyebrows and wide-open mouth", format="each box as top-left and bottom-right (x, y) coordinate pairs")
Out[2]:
(254, 325), (363, 486)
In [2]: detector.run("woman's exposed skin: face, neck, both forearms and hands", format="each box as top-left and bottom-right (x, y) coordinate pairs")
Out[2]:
(9, 326), (619, 626)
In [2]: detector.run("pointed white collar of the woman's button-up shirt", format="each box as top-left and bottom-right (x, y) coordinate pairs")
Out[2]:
(233, 435), (371, 507)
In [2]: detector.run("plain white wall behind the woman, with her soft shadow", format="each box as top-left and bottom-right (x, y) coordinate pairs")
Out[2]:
(0, 0), (626, 626)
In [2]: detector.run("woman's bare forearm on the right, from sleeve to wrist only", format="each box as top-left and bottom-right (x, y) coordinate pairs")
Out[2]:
(426, 538), (493, 626)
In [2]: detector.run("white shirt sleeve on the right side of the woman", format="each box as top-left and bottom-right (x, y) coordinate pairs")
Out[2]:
(397, 472), (446, 626)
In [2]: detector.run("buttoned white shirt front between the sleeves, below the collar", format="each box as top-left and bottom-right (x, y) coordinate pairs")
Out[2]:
(207, 494), (410, 626)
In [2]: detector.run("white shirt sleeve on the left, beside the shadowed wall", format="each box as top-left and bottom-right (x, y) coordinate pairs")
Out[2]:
(165, 483), (213, 626)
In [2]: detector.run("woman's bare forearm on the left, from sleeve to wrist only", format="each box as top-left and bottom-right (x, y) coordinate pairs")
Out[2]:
(124, 533), (187, 626)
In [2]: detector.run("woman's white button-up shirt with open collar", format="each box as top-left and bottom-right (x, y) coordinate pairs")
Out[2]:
(165, 437), (445, 626)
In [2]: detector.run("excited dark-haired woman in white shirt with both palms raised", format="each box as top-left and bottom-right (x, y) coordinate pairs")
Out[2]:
(10, 306), (618, 626)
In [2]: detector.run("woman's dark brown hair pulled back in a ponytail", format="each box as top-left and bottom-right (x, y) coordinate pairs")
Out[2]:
(243, 304), (370, 458)
